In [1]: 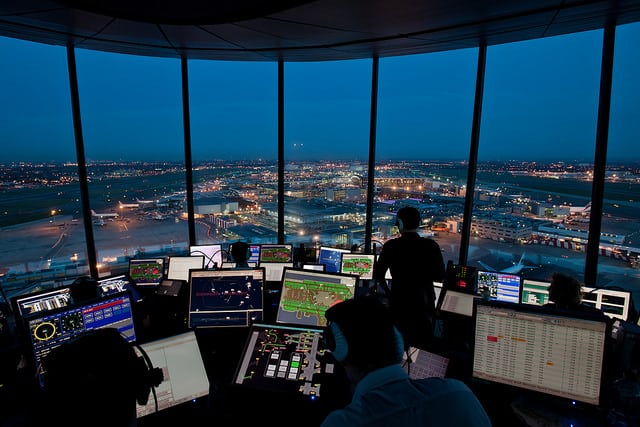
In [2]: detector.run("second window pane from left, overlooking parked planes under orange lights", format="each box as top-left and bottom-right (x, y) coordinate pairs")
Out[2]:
(76, 50), (189, 275)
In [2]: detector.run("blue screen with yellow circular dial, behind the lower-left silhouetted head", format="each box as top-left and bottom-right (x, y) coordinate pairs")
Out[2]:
(25, 292), (136, 380)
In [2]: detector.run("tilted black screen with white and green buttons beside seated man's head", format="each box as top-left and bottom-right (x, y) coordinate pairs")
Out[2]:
(233, 324), (334, 400)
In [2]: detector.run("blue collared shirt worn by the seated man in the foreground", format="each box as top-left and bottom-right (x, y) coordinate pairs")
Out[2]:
(321, 365), (491, 427)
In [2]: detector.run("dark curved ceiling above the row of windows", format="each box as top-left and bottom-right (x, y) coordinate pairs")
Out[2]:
(0, 0), (640, 61)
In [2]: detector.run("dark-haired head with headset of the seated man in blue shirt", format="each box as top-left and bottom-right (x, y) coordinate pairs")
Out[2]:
(325, 297), (404, 373)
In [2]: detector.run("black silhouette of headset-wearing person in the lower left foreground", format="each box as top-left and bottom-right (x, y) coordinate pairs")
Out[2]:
(38, 328), (162, 427)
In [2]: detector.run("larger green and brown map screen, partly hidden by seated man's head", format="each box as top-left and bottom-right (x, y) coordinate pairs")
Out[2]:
(276, 268), (358, 326)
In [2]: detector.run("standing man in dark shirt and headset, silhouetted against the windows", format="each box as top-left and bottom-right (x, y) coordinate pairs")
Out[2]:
(373, 207), (445, 348)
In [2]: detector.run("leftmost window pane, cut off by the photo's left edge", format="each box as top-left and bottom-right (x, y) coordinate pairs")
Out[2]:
(0, 37), (88, 298)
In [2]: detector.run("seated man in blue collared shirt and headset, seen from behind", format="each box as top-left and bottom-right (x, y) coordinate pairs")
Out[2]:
(321, 297), (491, 427)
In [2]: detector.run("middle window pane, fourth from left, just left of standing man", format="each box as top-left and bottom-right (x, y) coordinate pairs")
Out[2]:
(284, 60), (371, 261)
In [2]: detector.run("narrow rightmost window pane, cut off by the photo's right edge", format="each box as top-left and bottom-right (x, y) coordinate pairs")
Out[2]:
(596, 23), (640, 307)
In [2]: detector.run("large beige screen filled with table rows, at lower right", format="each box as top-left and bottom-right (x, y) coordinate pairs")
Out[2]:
(472, 300), (610, 405)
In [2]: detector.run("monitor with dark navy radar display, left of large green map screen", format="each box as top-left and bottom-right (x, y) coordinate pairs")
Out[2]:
(187, 267), (265, 328)
